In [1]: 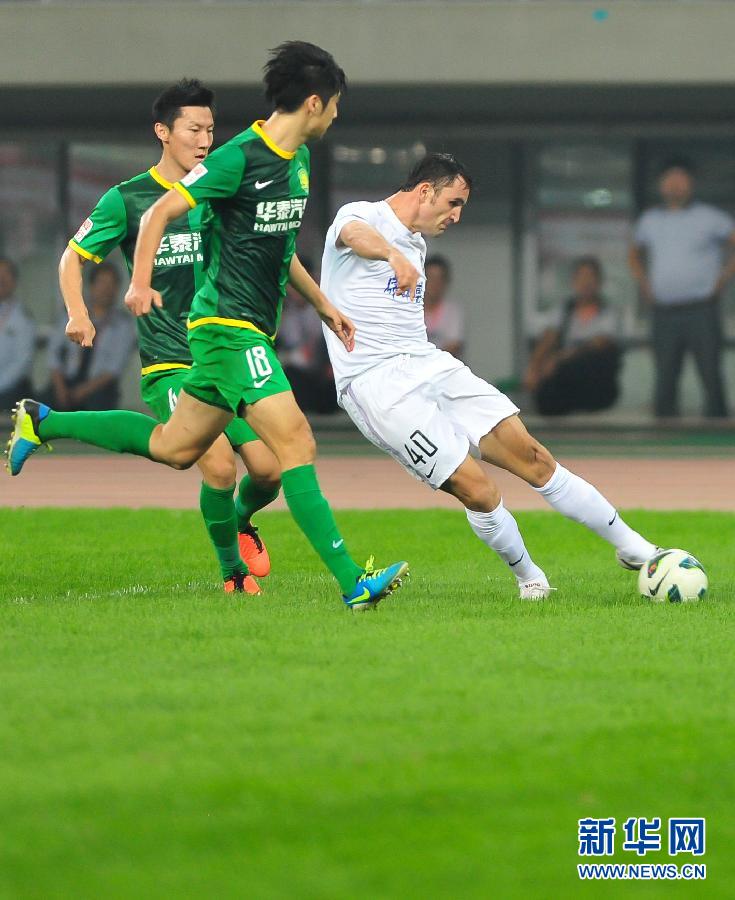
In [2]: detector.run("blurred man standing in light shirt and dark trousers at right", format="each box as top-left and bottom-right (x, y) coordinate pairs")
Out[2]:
(629, 160), (735, 417)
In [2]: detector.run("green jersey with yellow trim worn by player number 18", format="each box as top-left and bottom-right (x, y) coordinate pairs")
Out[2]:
(174, 122), (309, 337)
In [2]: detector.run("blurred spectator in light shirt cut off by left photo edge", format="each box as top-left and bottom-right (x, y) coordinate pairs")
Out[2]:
(0, 257), (36, 412)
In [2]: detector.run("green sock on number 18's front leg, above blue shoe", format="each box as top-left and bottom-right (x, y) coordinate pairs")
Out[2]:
(281, 466), (363, 594)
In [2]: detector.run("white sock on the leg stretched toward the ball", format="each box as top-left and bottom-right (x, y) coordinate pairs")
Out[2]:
(534, 463), (656, 565)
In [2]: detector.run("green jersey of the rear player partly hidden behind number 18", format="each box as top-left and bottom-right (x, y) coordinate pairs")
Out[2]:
(69, 166), (210, 375)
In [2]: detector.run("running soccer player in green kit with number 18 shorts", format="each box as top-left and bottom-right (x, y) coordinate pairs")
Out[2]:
(8, 41), (408, 609)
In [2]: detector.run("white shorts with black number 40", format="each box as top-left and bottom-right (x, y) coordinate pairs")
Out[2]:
(340, 350), (519, 490)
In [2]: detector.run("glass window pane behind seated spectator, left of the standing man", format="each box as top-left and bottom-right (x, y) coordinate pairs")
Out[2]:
(524, 141), (642, 337)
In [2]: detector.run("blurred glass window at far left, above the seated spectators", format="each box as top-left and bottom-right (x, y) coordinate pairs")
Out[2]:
(0, 141), (63, 334)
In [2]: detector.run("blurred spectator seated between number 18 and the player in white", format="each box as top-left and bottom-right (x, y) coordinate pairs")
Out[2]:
(276, 256), (337, 413)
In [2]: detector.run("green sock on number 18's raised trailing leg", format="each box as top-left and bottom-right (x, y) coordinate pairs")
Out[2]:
(38, 409), (158, 459)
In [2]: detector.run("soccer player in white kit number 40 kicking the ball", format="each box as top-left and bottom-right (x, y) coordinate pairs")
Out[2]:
(321, 153), (656, 600)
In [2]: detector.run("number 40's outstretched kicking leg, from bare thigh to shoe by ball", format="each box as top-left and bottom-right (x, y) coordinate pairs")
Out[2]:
(480, 416), (656, 568)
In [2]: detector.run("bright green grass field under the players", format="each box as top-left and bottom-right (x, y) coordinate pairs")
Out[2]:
(0, 510), (735, 900)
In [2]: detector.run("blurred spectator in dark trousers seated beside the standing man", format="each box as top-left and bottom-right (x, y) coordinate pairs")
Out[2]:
(525, 256), (620, 416)
